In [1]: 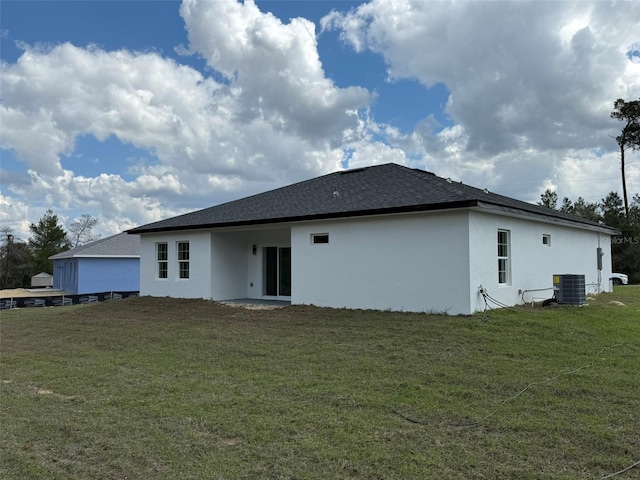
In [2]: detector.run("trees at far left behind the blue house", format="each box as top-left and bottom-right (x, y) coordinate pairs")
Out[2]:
(0, 209), (98, 288)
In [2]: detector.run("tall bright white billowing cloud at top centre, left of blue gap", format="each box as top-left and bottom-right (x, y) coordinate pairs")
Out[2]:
(180, 0), (369, 143)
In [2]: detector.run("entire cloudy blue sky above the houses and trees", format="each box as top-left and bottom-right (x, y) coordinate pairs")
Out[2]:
(0, 0), (640, 239)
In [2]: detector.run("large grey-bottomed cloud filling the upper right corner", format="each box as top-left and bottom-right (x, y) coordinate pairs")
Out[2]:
(323, 0), (640, 154)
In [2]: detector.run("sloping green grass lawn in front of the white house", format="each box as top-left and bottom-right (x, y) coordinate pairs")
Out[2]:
(0, 286), (640, 480)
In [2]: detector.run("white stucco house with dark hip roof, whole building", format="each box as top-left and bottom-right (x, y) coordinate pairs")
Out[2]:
(129, 164), (618, 314)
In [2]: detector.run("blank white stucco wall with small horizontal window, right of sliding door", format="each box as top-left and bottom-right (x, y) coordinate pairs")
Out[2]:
(291, 212), (470, 314)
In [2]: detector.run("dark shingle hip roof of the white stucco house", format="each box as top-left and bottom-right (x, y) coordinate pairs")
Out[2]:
(128, 163), (616, 234)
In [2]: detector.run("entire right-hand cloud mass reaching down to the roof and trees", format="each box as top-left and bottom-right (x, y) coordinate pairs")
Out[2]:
(321, 0), (640, 200)
